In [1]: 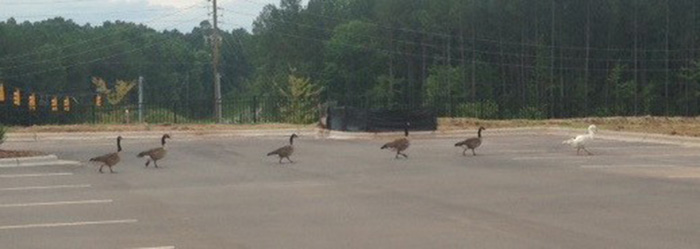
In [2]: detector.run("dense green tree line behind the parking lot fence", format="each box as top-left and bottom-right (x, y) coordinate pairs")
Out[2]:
(0, 0), (700, 121)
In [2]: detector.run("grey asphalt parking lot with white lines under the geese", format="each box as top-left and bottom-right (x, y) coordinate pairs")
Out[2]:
(0, 132), (700, 248)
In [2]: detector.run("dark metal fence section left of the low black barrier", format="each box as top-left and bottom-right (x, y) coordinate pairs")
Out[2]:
(0, 96), (319, 125)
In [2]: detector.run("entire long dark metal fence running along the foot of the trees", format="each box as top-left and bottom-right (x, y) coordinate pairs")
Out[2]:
(0, 96), (640, 126)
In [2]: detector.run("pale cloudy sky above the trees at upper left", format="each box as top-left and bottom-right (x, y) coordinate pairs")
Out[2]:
(0, 0), (294, 33)
